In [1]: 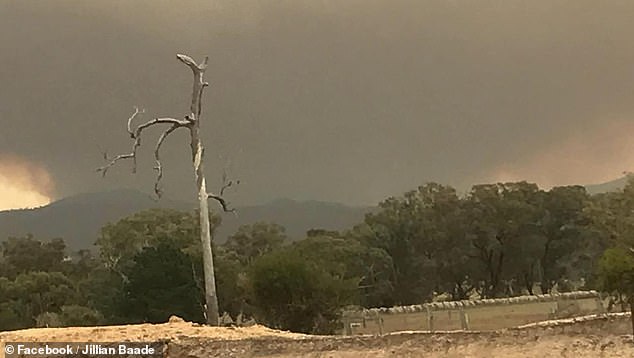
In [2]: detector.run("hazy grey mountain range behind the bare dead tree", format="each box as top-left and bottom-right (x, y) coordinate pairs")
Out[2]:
(0, 189), (372, 250)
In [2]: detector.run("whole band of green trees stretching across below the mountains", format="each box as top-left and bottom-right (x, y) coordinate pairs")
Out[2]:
(0, 178), (634, 334)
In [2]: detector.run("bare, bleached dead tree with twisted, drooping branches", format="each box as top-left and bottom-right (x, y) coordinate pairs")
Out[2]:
(97, 54), (237, 326)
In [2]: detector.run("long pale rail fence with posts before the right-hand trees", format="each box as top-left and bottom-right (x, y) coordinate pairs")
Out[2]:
(342, 291), (605, 335)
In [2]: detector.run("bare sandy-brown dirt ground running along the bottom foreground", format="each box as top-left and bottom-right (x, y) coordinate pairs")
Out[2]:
(0, 314), (634, 358)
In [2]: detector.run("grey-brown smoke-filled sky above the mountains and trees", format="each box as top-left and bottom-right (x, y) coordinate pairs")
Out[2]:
(0, 0), (634, 204)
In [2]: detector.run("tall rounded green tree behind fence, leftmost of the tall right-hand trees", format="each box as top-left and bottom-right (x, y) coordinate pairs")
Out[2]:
(358, 183), (477, 305)
